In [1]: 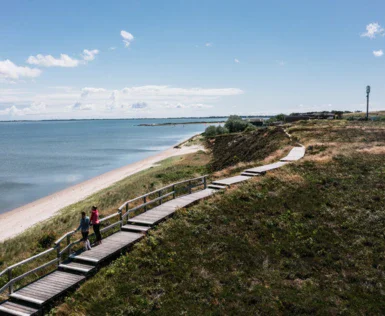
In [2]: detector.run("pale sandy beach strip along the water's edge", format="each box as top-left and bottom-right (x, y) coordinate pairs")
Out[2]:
(0, 141), (203, 241)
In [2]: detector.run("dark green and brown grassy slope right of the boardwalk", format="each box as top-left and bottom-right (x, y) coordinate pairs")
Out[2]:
(53, 122), (385, 315)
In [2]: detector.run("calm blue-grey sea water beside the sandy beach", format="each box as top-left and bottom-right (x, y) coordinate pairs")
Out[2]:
(0, 119), (223, 213)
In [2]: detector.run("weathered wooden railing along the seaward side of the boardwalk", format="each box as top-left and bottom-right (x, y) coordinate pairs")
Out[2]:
(0, 176), (207, 295)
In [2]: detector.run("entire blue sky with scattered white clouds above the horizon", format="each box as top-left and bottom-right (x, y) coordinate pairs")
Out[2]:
(0, 0), (385, 120)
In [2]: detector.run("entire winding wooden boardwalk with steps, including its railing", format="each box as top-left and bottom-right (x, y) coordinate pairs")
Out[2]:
(0, 146), (305, 316)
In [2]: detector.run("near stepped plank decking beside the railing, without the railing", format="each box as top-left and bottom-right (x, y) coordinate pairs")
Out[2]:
(0, 183), (217, 316)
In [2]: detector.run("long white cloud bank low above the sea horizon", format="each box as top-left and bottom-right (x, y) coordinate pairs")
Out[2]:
(0, 85), (240, 119)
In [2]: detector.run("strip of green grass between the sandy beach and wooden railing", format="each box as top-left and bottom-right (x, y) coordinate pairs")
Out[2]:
(0, 151), (211, 298)
